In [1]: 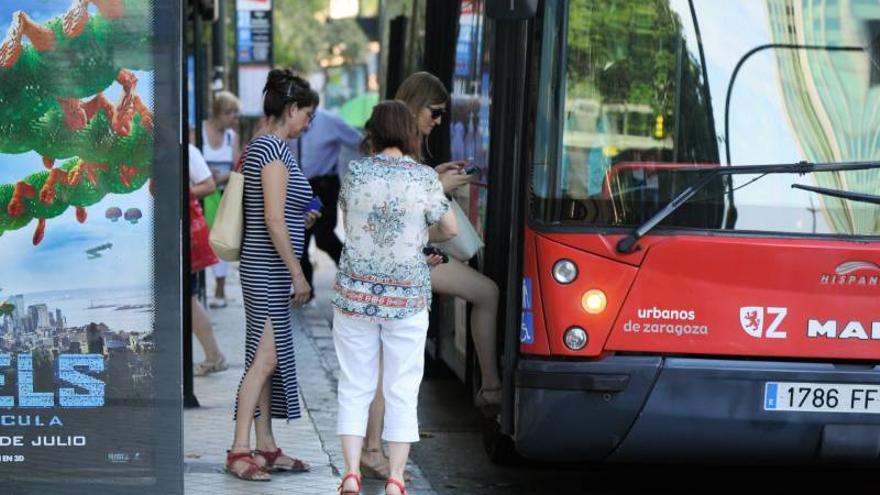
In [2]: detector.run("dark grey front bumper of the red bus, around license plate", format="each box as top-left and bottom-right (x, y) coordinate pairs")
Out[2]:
(514, 356), (880, 463)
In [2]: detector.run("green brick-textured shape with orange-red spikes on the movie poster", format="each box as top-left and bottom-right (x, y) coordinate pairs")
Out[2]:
(0, 0), (153, 245)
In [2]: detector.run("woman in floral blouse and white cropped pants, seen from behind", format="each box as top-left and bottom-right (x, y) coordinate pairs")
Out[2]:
(333, 101), (456, 495)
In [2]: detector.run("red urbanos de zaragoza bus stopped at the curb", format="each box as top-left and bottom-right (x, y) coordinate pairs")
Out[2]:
(390, 0), (880, 463)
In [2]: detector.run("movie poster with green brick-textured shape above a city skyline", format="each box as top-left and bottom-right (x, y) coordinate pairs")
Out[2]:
(0, 0), (179, 493)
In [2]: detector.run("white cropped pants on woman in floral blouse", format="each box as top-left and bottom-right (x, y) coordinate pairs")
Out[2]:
(333, 310), (428, 442)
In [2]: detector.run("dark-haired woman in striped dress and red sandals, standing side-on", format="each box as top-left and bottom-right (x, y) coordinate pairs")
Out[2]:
(226, 69), (318, 481)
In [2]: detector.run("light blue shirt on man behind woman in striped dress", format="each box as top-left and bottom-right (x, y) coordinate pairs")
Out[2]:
(287, 109), (361, 179)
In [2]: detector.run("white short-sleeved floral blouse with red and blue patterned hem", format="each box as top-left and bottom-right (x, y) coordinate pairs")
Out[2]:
(333, 155), (449, 320)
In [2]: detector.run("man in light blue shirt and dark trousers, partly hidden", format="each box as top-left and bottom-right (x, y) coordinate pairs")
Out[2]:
(287, 109), (361, 285)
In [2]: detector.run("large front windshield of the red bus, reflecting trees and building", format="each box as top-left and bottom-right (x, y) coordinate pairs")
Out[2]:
(531, 0), (880, 236)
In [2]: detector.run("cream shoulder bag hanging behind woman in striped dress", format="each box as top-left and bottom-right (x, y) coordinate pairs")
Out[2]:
(208, 171), (244, 261)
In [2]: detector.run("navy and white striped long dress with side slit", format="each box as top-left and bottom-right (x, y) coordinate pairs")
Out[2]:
(239, 134), (312, 420)
